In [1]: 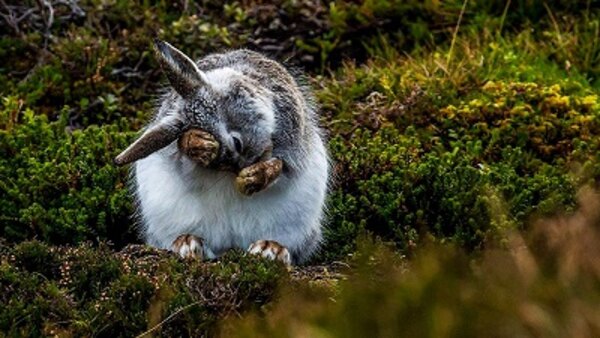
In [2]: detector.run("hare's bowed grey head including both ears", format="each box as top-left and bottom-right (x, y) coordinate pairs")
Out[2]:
(115, 40), (275, 170)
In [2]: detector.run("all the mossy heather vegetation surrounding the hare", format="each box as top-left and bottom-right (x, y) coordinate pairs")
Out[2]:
(0, 0), (600, 336)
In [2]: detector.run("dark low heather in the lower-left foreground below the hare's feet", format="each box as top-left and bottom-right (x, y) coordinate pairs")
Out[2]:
(0, 241), (287, 337)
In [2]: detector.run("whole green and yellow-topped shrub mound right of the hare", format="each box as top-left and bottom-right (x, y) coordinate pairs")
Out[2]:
(318, 35), (600, 259)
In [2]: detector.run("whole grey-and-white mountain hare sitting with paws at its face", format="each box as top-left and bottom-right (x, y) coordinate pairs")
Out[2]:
(115, 40), (329, 264)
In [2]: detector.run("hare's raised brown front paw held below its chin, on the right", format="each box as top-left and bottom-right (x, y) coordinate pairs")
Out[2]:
(235, 158), (283, 196)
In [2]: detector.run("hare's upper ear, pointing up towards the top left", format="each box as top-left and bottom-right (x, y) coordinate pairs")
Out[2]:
(154, 39), (207, 98)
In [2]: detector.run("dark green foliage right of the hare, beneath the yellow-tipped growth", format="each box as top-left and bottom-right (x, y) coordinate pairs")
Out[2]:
(323, 123), (575, 259)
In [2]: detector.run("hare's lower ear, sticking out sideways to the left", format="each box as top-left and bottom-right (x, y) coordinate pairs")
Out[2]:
(114, 118), (185, 166)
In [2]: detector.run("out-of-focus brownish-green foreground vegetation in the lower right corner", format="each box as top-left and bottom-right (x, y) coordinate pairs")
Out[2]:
(221, 190), (600, 337)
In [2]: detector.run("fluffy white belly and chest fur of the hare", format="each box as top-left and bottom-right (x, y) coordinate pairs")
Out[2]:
(135, 131), (328, 258)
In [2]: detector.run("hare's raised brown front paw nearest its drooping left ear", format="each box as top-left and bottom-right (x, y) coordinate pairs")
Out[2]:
(177, 129), (219, 167)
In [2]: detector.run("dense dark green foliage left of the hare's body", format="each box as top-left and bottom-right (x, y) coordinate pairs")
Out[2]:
(0, 98), (135, 244)
